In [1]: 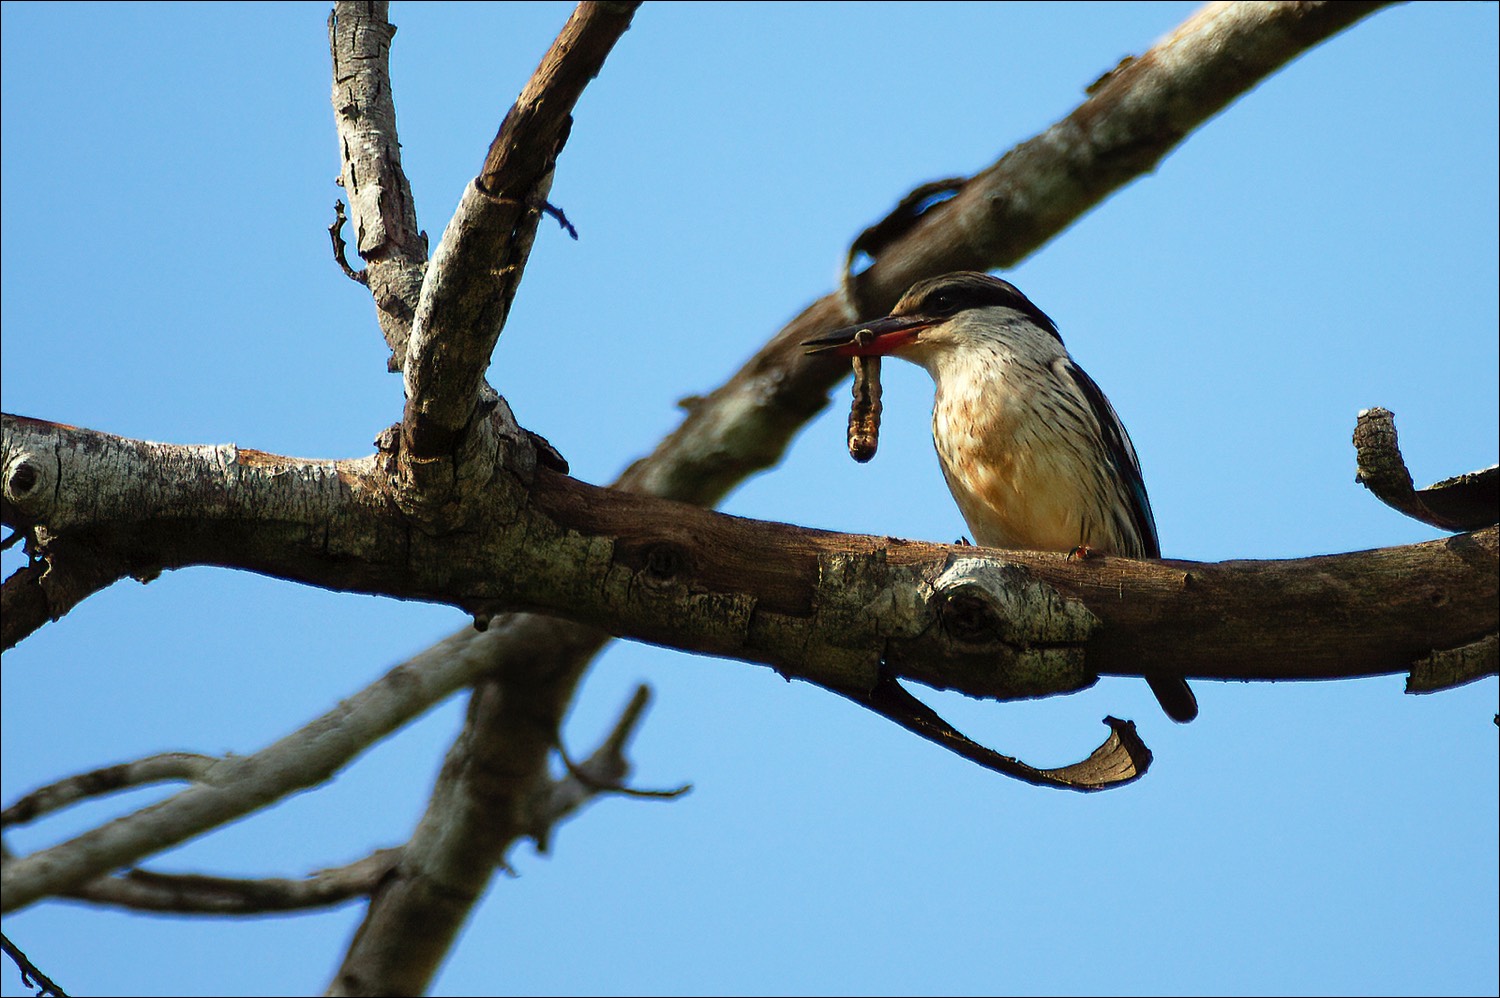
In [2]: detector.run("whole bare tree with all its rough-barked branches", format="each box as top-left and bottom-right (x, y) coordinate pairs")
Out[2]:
(3, 3), (1500, 993)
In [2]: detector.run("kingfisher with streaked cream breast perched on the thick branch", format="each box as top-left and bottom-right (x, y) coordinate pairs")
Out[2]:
(803, 272), (1199, 722)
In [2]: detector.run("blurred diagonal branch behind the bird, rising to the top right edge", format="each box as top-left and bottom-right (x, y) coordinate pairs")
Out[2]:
(617, 3), (1385, 506)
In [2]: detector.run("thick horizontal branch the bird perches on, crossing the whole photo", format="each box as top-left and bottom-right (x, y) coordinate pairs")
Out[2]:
(5, 416), (1497, 698)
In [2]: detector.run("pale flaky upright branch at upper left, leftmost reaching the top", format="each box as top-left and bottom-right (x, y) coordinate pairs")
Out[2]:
(329, 0), (428, 371)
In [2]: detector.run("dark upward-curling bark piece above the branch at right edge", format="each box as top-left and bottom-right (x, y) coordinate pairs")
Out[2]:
(1355, 407), (1500, 530)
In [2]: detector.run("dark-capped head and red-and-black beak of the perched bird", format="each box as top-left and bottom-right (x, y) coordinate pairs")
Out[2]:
(803, 270), (1062, 363)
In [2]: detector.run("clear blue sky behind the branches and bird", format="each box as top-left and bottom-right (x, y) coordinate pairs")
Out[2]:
(0, 3), (1500, 995)
